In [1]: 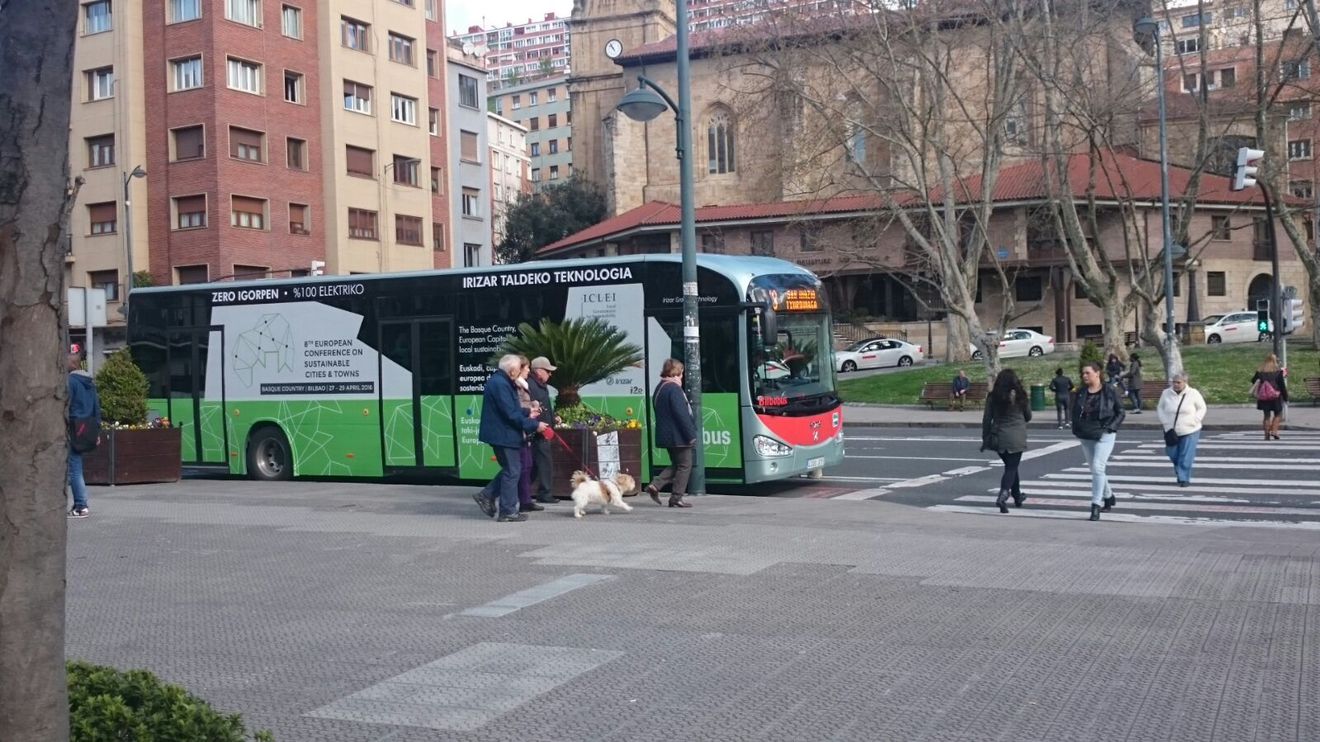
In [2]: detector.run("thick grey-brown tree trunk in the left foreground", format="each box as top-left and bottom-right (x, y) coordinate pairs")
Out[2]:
(0, 0), (79, 742)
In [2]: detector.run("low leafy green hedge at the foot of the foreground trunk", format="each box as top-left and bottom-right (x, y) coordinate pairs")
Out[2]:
(67, 661), (275, 742)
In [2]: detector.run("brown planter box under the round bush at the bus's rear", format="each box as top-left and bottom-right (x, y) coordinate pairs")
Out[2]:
(83, 428), (183, 485)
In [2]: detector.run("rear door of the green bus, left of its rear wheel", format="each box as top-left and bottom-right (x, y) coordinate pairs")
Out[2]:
(166, 325), (230, 466)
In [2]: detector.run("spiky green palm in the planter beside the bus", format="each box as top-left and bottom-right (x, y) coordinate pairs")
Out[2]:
(500, 317), (642, 409)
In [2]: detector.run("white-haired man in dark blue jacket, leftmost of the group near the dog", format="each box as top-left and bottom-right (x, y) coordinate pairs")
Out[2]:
(473, 354), (549, 523)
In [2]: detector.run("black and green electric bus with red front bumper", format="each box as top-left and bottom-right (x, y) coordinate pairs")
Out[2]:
(128, 255), (843, 483)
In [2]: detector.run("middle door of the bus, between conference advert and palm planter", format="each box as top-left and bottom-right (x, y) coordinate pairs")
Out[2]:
(379, 317), (458, 473)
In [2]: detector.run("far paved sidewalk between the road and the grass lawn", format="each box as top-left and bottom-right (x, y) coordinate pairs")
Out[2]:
(843, 401), (1320, 430)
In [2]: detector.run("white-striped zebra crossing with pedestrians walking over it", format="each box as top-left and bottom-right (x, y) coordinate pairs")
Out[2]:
(928, 432), (1320, 531)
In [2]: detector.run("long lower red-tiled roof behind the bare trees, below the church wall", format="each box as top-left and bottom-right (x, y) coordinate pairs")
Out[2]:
(539, 153), (1293, 253)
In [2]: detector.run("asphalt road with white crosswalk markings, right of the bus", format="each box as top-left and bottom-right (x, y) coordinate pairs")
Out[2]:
(801, 428), (1320, 529)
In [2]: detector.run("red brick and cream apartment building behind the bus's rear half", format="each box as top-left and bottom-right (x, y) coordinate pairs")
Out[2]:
(69, 0), (453, 345)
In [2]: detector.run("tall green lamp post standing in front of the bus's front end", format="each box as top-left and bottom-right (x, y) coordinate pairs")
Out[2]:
(616, 13), (706, 495)
